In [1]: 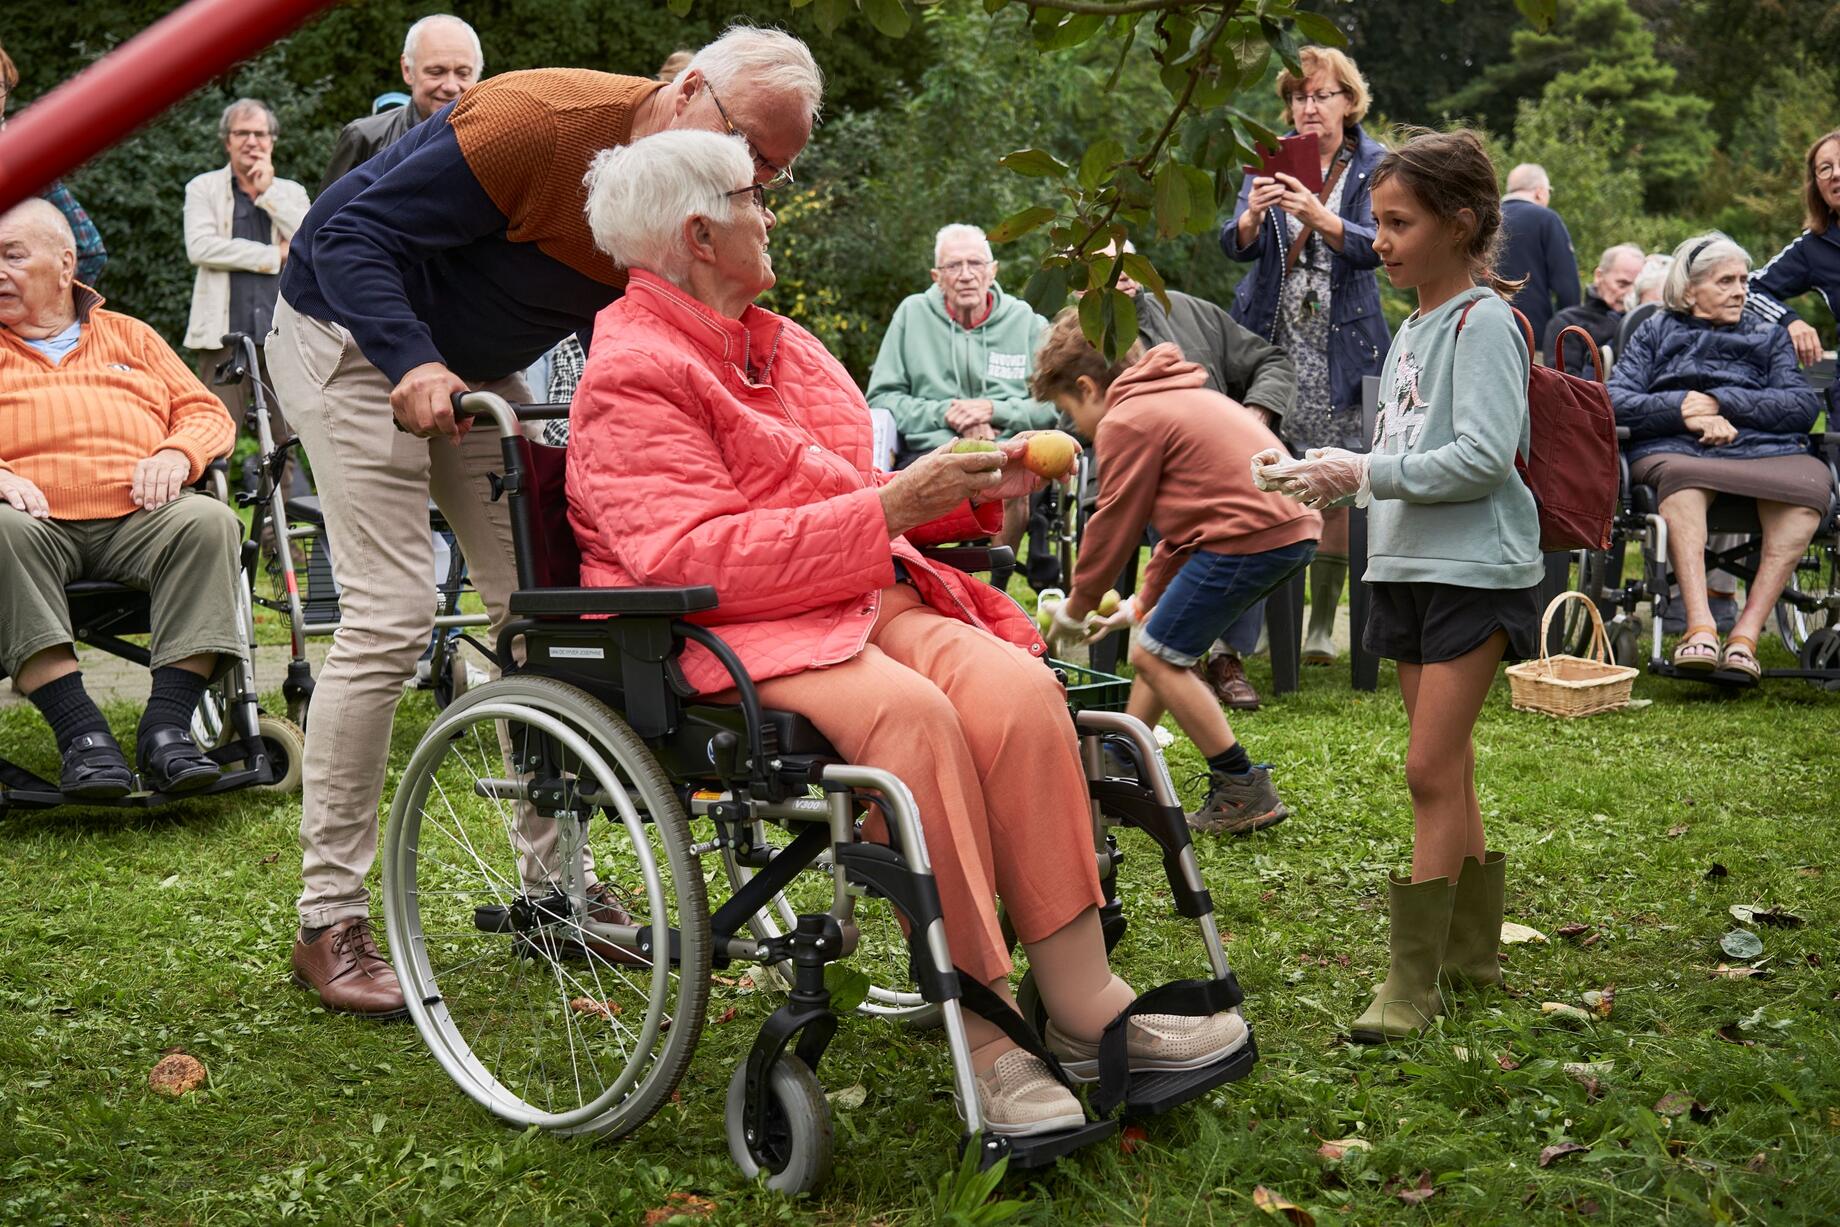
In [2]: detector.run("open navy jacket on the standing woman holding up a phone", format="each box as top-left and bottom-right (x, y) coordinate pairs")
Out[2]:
(1220, 123), (1393, 408)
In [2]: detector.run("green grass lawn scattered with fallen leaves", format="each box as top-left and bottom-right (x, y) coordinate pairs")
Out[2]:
(0, 647), (1840, 1225)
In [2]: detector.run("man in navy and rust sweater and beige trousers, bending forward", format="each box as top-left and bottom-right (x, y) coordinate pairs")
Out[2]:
(269, 26), (824, 1017)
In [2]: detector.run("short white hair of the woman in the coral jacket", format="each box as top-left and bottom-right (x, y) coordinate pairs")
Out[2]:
(583, 129), (754, 285)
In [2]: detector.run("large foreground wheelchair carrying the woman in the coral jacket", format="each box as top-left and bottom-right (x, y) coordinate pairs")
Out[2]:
(383, 394), (1257, 1192)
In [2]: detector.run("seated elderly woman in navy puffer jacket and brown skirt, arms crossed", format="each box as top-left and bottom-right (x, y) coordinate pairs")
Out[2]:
(1610, 234), (1831, 677)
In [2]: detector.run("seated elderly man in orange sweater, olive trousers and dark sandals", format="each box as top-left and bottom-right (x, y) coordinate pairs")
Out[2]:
(0, 201), (243, 800)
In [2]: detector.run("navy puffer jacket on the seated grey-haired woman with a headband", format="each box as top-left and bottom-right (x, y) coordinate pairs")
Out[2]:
(1610, 311), (1822, 460)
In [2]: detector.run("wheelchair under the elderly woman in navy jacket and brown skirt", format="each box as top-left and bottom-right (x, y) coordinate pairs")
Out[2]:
(1564, 427), (1840, 692)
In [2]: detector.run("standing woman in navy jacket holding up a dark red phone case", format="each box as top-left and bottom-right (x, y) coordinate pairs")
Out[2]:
(1220, 46), (1393, 664)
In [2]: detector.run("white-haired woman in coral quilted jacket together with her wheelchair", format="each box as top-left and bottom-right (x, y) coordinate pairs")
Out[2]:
(373, 131), (1257, 1190)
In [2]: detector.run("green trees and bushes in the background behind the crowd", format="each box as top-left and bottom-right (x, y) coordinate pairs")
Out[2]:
(0, 0), (1840, 375)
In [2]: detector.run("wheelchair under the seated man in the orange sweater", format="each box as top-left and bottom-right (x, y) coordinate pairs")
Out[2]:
(0, 460), (304, 815)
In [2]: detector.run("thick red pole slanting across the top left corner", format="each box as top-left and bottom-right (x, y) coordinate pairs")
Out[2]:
(0, 0), (333, 210)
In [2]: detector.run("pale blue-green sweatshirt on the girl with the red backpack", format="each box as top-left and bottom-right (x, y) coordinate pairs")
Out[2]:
(1363, 289), (1546, 589)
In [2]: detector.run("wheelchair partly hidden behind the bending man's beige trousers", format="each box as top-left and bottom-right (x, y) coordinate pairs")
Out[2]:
(215, 333), (491, 727)
